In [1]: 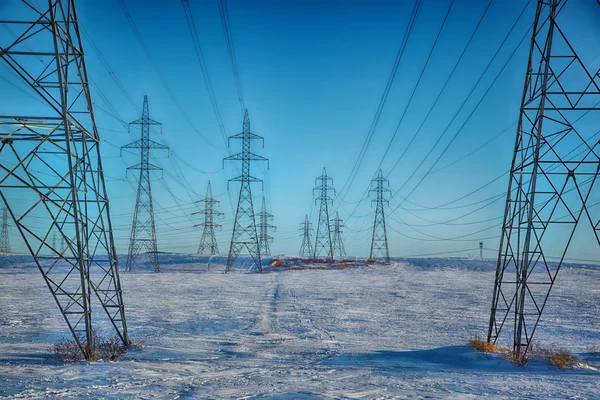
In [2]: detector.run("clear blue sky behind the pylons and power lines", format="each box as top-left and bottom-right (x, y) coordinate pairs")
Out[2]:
(0, 0), (600, 258)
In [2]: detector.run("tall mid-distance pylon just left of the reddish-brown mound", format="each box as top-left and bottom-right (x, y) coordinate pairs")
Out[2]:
(223, 110), (268, 272)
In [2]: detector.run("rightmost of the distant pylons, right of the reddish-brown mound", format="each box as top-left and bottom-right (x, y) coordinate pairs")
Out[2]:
(369, 170), (390, 263)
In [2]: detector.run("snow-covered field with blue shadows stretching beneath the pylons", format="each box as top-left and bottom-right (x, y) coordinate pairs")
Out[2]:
(0, 255), (600, 399)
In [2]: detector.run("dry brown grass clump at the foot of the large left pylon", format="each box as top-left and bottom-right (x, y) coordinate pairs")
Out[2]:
(54, 332), (127, 364)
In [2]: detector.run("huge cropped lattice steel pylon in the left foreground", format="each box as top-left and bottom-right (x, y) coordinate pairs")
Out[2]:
(0, 0), (129, 359)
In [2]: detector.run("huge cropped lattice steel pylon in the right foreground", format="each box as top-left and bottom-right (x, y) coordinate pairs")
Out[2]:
(487, 0), (600, 357)
